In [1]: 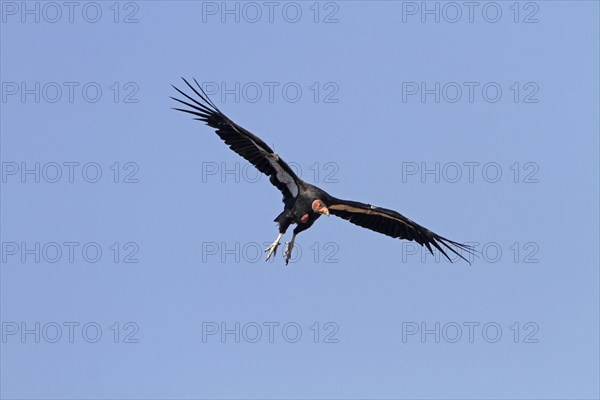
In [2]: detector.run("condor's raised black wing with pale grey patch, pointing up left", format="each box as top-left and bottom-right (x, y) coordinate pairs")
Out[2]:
(171, 78), (300, 200)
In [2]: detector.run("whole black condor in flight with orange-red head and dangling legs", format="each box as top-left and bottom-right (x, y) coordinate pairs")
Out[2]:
(171, 78), (473, 265)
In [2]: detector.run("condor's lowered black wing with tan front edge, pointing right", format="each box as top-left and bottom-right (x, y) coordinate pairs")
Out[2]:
(327, 199), (474, 264)
